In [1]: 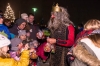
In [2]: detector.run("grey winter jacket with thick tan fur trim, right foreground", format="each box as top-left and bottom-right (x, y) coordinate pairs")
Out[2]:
(71, 42), (100, 66)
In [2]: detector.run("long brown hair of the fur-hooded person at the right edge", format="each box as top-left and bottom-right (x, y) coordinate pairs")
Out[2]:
(87, 33), (100, 48)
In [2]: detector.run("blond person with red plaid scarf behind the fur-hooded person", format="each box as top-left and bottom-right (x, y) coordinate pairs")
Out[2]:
(67, 19), (100, 64)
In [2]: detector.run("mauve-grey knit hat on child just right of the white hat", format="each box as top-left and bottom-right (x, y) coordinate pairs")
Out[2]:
(11, 38), (22, 51)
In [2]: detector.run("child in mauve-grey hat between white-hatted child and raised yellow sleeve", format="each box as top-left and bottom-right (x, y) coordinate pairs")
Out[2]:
(10, 38), (23, 61)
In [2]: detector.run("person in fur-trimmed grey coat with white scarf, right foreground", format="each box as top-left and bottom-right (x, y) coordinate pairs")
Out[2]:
(71, 33), (100, 66)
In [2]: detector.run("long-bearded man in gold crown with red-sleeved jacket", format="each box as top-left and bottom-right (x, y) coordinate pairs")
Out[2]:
(47, 4), (75, 66)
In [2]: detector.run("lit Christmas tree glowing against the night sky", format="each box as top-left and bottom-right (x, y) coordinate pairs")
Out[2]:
(4, 3), (15, 22)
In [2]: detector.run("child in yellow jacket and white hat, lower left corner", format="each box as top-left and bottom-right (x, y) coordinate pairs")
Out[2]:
(0, 34), (33, 66)
